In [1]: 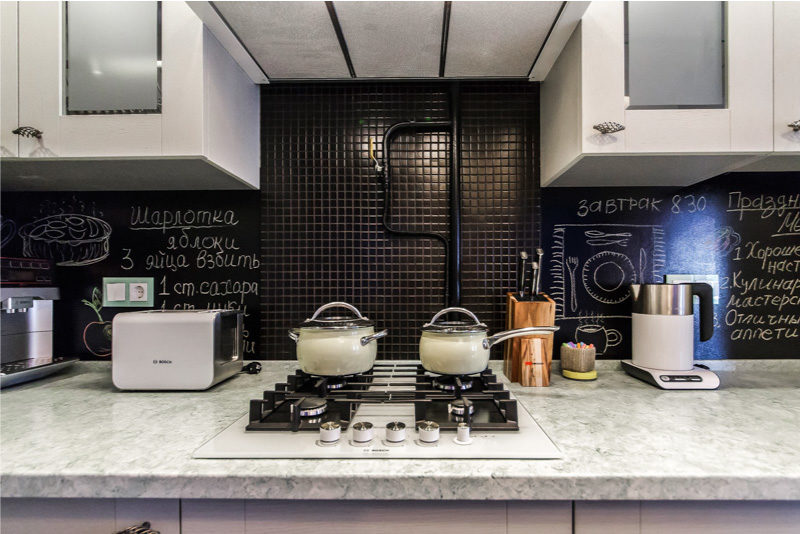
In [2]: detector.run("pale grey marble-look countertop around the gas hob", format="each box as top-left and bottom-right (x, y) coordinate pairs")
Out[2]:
(0, 360), (800, 500)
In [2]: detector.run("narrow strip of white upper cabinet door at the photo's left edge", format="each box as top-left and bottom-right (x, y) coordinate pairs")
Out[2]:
(0, 2), (19, 157)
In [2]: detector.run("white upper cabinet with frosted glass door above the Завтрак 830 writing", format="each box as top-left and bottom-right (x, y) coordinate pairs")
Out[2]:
(541, 2), (788, 186)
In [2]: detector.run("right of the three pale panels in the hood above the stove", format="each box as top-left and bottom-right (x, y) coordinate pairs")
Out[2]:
(445, 2), (562, 77)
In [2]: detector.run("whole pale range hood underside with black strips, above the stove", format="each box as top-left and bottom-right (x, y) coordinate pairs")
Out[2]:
(188, 1), (589, 83)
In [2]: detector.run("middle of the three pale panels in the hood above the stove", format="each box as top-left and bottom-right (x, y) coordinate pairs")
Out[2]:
(334, 2), (444, 78)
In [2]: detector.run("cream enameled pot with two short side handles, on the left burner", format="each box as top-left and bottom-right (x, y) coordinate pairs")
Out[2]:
(289, 302), (388, 376)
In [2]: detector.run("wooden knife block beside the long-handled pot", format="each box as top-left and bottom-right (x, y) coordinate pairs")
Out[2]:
(503, 293), (556, 386)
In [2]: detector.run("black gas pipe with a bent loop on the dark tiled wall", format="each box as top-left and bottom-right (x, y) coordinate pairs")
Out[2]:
(375, 82), (461, 306)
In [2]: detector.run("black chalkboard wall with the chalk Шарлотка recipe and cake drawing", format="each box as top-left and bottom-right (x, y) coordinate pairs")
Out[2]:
(2, 191), (261, 359)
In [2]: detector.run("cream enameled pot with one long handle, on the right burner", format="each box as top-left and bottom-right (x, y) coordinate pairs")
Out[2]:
(419, 308), (559, 375)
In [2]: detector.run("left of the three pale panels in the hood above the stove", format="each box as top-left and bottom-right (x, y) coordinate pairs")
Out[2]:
(214, 2), (350, 80)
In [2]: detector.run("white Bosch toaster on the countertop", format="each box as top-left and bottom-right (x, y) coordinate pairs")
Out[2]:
(111, 310), (242, 390)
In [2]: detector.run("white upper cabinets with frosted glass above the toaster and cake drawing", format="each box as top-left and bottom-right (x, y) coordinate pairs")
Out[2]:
(0, 2), (260, 190)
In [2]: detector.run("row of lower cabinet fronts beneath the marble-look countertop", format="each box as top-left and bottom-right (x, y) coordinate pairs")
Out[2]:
(0, 499), (800, 534)
